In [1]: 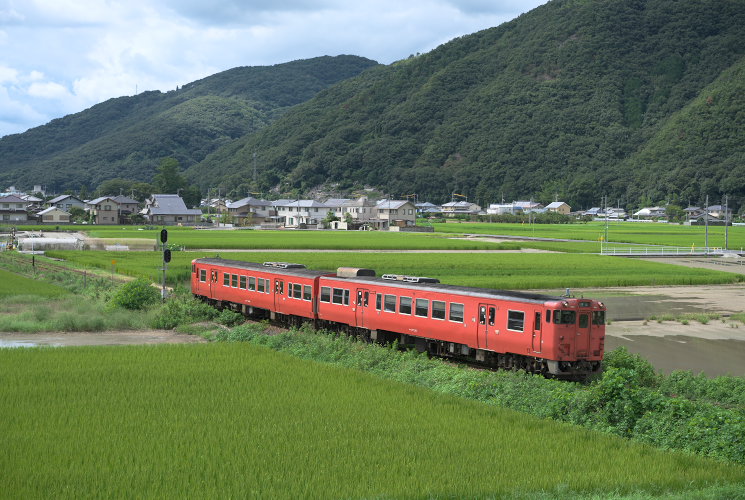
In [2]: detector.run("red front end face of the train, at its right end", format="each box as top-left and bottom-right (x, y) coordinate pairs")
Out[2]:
(542, 298), (605, 380)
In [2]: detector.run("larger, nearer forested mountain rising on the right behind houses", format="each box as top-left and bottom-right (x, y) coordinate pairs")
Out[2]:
(187, 0), (745, 208)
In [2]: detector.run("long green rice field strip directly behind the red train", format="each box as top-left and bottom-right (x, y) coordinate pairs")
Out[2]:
(47, 251), (745, 290)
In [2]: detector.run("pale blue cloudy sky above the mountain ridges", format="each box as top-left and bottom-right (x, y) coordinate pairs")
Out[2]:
(0, 0), (547, 137)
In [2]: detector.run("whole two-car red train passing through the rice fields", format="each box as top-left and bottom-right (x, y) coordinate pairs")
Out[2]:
(191, 258), (605, 379)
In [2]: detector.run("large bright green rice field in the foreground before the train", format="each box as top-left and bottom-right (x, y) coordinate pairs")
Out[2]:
(0, 343), (745, 498)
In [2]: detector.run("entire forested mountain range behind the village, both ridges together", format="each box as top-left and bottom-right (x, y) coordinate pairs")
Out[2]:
(0, 0), (745, 209)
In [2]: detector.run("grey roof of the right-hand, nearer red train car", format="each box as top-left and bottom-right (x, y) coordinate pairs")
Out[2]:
(326, 275), (566, 303)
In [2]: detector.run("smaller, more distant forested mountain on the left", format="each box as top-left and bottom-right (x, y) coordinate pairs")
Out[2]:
(0, 56), (377, 192)
